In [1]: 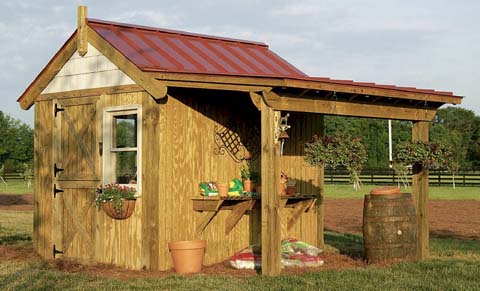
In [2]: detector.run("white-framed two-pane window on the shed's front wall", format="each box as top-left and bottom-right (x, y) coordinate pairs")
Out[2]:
(103, 105), (142, 195)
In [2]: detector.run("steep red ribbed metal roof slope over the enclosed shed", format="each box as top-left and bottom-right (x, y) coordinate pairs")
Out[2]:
(88, 19), (307, 78)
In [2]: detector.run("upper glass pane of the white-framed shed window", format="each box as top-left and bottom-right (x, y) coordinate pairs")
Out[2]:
(113, 114), (137, 148)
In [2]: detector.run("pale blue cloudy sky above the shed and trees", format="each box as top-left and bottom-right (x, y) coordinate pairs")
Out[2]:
(0, 0), (480, 124)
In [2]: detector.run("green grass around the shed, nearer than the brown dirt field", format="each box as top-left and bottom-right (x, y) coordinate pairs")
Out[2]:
(0, 211), (480, 290)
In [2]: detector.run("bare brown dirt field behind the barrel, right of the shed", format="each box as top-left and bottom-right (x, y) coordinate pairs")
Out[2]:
(325, 199), (480, 240)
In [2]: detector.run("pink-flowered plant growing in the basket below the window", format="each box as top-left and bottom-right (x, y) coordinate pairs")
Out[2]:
(95, 184), (137, 210)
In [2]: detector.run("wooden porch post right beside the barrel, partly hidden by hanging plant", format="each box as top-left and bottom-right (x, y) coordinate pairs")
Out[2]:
(412, 121), (429, 260)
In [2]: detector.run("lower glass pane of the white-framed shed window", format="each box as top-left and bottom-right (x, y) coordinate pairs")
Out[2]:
(112, 151), (137, 184)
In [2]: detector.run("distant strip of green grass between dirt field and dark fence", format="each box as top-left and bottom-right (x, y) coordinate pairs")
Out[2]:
(325, 184), (480, 200)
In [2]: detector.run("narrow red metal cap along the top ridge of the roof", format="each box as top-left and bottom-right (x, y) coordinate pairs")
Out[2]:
(87, 18), (268, 48)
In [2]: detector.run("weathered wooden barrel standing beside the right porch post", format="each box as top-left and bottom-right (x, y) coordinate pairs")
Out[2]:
(363, 193), (417, 262)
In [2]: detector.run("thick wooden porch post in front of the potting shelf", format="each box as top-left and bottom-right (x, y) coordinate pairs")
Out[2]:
(261, 98), (282, 276)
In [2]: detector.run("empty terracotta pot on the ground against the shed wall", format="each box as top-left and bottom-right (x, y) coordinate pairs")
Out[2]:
(168, 240), (206, 274)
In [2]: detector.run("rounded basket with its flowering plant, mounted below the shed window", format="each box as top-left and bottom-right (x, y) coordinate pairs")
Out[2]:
(95, 184), (137, 219)
